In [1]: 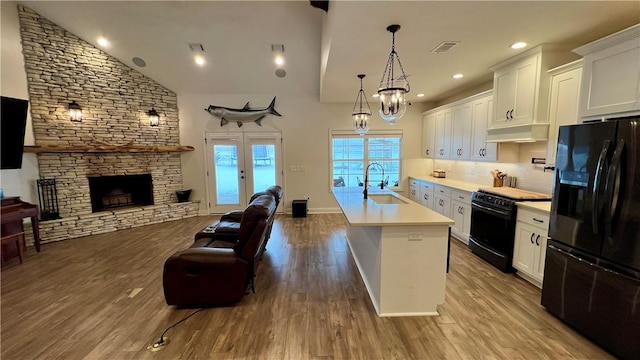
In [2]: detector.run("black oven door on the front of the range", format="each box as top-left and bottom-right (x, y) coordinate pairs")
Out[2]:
(469, 201), (516, 272)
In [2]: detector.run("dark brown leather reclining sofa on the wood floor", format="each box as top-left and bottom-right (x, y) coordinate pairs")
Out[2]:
(163, 193), (277, 307)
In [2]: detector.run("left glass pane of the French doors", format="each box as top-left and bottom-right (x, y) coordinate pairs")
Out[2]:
(213, 145), (240, 204)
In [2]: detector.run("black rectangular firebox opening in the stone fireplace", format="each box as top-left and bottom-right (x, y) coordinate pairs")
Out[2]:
(89, 174), (153, 212)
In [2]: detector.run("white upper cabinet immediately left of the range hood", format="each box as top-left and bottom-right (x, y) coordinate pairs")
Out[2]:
(469, 93), (498, 161)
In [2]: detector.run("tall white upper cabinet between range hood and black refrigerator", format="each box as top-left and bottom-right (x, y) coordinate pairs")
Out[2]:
(546, 60), (582, 166)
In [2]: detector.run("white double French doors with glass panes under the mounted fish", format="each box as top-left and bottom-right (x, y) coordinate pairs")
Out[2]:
(205, 132), (283, 214)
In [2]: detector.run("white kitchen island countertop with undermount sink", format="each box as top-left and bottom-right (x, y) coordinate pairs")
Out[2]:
(333, 188), (454, 226)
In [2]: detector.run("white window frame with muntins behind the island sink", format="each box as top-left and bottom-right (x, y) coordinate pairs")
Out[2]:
(329, 130), (403, 192)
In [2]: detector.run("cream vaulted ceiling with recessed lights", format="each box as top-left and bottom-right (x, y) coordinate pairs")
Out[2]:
(20, 0), (640, 102)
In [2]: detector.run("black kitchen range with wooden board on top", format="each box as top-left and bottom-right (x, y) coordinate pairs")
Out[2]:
(469, 188), (551, 272)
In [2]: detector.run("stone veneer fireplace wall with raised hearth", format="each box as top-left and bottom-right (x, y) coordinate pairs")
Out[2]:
(18, 5), (198, 242)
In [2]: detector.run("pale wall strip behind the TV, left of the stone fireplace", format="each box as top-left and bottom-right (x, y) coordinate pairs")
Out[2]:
(0, 1), (38, 204)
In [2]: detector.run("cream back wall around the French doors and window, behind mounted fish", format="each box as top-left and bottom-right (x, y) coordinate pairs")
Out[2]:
(178, 93), (428, 212)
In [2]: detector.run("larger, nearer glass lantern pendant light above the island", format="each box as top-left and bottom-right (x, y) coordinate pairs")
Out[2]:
(378, 25), (410, 124)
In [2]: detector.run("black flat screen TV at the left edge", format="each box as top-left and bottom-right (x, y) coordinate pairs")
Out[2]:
(0, 96), (29, 170)
